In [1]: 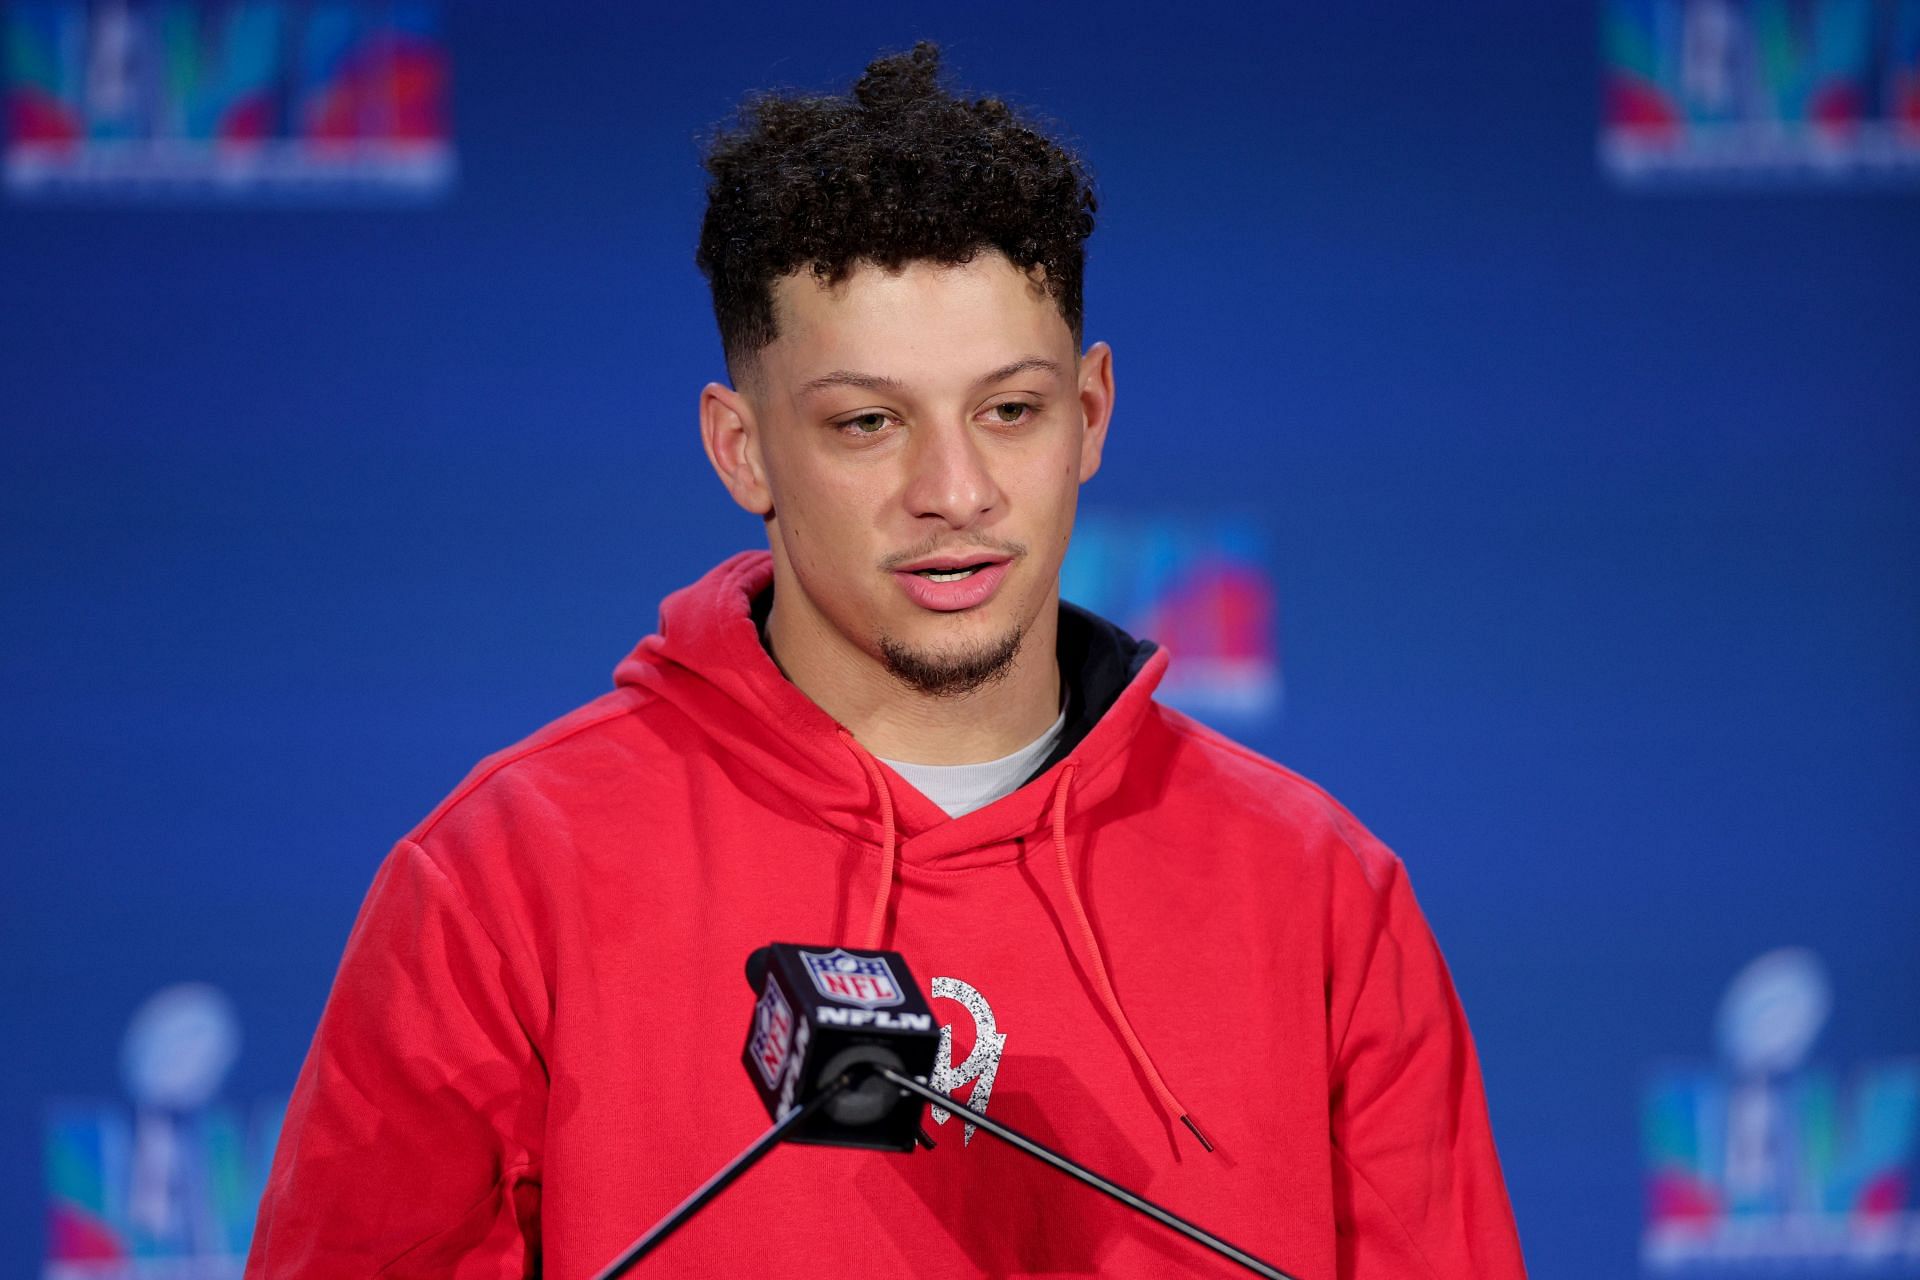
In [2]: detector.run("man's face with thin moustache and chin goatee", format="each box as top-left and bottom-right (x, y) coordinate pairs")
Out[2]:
(721, 253), (1112, 695)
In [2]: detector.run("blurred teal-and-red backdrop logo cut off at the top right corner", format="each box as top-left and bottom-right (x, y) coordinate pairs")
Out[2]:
(1599, 0), (1920, 184)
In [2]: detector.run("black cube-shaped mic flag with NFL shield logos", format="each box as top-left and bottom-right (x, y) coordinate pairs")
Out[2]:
(741, 942), (939, 1151)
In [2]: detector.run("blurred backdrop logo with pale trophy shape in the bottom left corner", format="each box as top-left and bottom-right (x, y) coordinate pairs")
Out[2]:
(42, 983), (286, 1280)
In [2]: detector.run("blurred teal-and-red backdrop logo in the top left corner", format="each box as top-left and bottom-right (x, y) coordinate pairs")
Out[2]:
(0, 0), (453, 200)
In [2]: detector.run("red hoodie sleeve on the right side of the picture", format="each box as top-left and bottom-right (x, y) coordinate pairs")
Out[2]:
(1329, 846), (1526, 1280)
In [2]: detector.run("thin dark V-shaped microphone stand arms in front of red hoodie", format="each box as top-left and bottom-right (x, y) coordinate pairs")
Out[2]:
(593, 1063), (1296, 1280)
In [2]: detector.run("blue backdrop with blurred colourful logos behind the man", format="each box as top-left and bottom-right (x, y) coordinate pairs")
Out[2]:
(0, 0), (1920, 1280)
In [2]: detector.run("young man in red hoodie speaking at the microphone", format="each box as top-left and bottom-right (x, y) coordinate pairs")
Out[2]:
(248, 46), (1523, 1280)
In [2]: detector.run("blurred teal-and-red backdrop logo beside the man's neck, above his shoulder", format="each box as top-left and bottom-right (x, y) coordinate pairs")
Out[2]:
(1060, 512), (1281, 727)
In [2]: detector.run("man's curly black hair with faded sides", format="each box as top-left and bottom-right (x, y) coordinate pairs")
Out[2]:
(693, 42), (1094, 374)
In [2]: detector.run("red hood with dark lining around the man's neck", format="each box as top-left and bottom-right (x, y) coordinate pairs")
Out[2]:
(614, 551), (1167, 869)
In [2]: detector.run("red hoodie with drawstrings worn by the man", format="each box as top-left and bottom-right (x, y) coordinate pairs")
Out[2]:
(248, 553), (1524, 1280)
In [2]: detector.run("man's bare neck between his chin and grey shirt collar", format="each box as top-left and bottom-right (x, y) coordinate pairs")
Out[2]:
(766, 593), (1060, 764)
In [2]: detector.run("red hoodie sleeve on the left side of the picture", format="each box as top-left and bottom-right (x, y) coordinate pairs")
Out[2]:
(246, 842), (547, 1280)
